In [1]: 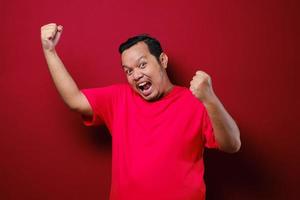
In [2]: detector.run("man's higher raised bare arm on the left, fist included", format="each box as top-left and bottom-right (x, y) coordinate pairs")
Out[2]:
(41, 23), (93, 116)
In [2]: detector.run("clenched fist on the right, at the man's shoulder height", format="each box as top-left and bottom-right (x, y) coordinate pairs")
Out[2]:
(190, 71), (214, 103)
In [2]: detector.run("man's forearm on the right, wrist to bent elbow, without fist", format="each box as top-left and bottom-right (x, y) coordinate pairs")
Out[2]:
(203, 94), (241, 153)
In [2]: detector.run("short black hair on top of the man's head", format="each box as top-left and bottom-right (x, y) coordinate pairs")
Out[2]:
(119, 34), (163, 62)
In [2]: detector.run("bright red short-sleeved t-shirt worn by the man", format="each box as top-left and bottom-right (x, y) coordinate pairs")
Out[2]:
(82, 84), (217, 200)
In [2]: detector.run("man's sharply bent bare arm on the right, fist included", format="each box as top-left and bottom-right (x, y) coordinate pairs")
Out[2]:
(190, 71), (241, 153)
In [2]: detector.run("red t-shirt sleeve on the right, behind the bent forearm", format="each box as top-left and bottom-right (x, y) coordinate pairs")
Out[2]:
(202, 108), (218, 148)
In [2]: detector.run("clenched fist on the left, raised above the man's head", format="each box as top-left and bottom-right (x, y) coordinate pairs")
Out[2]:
(41, 23), (63, 51)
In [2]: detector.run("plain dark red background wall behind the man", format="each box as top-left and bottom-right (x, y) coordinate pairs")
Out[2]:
(0, 0), (300, 200)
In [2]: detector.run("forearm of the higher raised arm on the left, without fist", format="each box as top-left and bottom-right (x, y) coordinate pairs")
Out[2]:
(43, 49), (80, 109)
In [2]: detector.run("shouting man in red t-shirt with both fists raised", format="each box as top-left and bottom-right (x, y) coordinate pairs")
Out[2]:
(41, 23), (241, 200)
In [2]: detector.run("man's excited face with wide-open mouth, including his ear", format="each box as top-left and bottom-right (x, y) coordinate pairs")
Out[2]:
(121, 42), (170, 101)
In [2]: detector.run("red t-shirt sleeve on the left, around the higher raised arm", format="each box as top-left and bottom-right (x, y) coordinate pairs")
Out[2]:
(81, 85), (118, 127)
